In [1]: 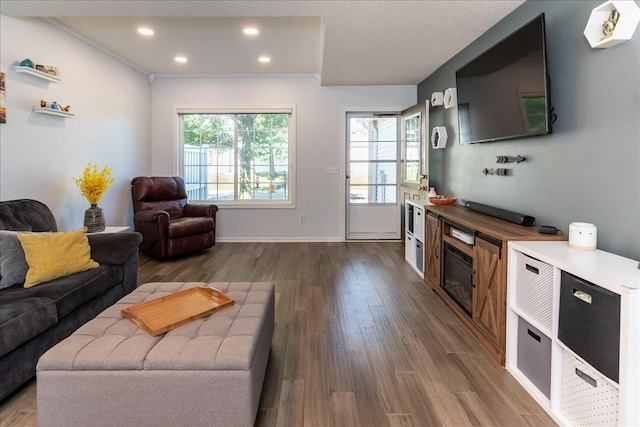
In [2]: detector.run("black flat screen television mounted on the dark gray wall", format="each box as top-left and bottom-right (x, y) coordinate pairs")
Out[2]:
(456, 14), (551, 143)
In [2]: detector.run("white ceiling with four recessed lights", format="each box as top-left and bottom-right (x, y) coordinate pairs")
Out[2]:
(0, 0), (525, 86)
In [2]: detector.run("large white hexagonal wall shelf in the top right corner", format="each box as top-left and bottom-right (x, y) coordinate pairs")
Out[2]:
(584, 1), (640, 48)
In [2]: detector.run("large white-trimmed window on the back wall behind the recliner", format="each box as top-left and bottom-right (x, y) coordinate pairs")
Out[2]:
(178, 108), (295, 206)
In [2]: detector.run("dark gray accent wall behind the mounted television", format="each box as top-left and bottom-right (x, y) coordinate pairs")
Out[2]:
(418, 0), (640, 260)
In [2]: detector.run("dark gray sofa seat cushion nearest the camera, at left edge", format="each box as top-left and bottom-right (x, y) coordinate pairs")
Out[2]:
(0, 294), (58, 356)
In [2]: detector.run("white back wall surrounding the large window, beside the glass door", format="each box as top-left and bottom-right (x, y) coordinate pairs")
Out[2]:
(151, 77), (416, 241)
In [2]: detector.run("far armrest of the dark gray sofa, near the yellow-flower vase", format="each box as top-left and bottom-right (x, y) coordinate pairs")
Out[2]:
(87, 233), (142, 265)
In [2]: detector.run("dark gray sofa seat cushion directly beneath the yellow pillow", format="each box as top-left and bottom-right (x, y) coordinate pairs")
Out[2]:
(0, 265), (123, 319)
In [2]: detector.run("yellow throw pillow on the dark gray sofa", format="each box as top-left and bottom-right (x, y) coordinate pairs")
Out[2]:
(18, 228), (100, 288)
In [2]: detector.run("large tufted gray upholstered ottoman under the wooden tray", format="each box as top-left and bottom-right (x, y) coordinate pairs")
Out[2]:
(36, 282), (274, 427)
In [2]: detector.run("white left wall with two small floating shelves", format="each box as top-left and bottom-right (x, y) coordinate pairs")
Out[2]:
(0, 15), (151, 230)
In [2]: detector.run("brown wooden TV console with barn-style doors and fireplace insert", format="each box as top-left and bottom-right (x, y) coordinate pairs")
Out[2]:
(424, 205), (567, 366)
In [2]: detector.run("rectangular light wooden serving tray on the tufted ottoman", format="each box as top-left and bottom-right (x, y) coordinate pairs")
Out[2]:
(121, 286), (234, 336)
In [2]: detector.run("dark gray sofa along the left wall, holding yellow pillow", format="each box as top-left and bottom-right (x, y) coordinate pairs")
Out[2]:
(0, 199), (142, 400)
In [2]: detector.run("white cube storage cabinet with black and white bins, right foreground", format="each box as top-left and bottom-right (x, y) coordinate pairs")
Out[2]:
(506, 241), (640, 426)
